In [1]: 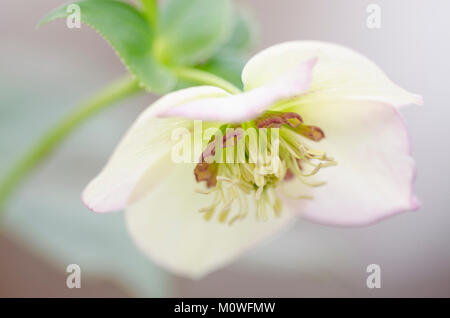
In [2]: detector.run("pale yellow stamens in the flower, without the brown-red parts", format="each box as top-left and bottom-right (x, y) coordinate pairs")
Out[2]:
(197, 113), (336, 225)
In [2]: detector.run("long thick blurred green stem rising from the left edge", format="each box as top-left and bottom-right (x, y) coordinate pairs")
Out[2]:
(0, 76), (140, 212)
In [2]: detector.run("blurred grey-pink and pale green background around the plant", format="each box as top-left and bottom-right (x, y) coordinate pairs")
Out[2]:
(0, 0), (450, 297)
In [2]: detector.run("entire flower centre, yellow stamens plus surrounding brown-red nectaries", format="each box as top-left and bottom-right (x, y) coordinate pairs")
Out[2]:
(194, 112), (336, 225)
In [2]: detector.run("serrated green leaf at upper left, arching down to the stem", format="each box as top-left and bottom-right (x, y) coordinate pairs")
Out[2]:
(39, 0), (176, 93)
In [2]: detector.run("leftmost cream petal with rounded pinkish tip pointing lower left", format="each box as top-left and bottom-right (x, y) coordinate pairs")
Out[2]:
(82, 86), (227, 212)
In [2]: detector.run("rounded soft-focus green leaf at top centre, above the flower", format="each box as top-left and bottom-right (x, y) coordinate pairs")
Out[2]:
(156, 0), (233, 65)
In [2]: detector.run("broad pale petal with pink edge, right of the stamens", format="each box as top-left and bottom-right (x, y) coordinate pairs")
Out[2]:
(286, 101), (419, 226)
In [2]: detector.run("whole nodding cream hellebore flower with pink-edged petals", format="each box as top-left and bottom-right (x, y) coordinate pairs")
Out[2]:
(83, 41), (422, 277)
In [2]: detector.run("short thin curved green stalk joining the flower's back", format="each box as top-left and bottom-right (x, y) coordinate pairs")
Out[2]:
(175, 67), (242, 94)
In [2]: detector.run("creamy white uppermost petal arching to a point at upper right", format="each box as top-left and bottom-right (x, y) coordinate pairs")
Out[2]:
(242, 41), (423, 107)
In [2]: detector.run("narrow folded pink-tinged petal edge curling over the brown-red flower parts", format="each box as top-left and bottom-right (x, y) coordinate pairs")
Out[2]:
(159, 58), (316, 123)
